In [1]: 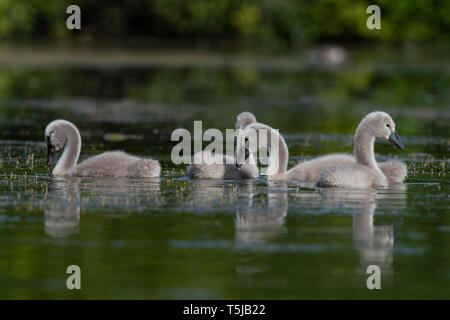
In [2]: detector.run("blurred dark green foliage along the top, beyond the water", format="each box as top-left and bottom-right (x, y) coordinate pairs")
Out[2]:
(0, 0), (450, 48)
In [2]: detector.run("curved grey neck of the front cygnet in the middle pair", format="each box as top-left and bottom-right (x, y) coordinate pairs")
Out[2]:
(267, 129), (289, 180)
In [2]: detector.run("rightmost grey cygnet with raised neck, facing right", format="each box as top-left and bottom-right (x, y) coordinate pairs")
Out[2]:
(317, 111), (407, 188)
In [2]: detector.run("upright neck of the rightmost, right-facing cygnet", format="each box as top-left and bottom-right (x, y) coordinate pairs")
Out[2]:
(354, 125), (383, 174)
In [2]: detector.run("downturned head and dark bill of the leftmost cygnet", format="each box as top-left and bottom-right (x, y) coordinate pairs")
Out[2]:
(45, 120), (79, 168)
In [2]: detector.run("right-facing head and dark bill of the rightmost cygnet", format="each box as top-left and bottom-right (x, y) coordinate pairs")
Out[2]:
(356, 111), (404, 150)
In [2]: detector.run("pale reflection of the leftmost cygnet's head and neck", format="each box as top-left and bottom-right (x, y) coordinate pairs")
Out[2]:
(45, 179), (80, 237)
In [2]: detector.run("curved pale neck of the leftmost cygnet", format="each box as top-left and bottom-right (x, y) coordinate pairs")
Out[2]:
(53, 123), (81, 175)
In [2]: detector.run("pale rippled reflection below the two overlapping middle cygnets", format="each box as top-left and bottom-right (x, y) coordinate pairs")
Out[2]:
(187, 180), (288, 287)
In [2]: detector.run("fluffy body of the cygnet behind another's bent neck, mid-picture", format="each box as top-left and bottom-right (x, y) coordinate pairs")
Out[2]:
(186, 151), (259, 180)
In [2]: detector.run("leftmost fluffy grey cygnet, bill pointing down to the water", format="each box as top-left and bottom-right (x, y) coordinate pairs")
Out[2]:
(45, 120), (161, 178)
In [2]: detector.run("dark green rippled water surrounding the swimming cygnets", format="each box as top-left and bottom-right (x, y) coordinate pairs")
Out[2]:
(0, 46), (450, 299)
